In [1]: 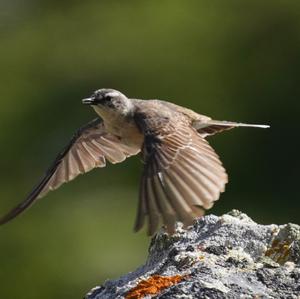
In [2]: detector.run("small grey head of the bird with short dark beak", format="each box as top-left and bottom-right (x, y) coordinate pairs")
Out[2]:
(82, 88), (132, 116)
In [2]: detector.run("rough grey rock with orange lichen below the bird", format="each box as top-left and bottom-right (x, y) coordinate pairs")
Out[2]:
(85, 210), (300, 299)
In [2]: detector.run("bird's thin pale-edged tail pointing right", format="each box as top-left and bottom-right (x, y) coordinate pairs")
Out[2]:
(193, 119), (269, 137)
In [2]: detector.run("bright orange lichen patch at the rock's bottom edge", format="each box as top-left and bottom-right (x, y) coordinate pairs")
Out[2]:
(125, 275), (184, 299)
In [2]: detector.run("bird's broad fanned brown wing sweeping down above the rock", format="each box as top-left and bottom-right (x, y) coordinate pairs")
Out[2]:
(135, 110), (227, 235)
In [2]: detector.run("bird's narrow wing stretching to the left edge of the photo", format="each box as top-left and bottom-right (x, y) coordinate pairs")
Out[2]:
(0, 118), (139, 224)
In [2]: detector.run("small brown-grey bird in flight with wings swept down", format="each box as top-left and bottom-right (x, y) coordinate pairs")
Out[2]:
(0, 88), (269, 236)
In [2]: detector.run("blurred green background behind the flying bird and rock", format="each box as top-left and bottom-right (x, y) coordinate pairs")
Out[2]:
(0, 0), (300, 299)
